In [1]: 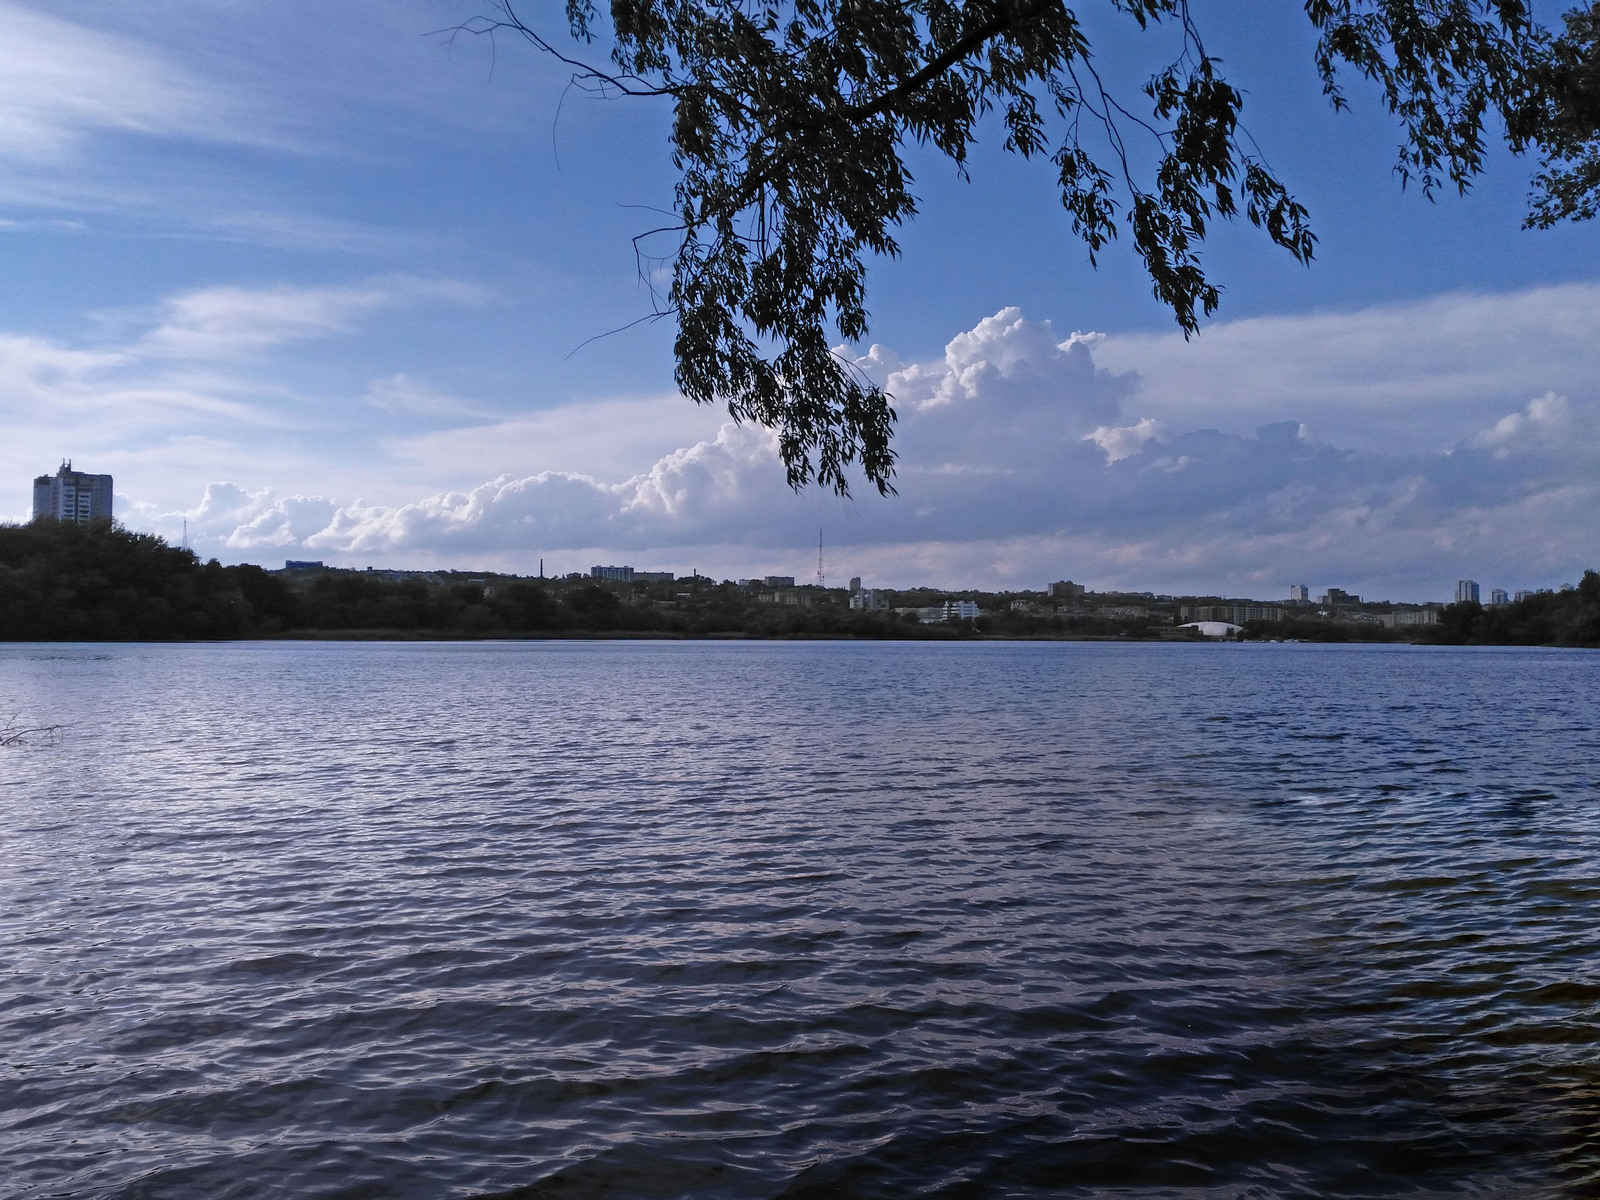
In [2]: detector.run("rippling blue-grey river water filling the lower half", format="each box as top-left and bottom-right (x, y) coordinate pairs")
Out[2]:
(0, 642), (1600, 1200)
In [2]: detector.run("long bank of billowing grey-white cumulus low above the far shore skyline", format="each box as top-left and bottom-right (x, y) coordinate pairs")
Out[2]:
(144, 299), (1600, 595)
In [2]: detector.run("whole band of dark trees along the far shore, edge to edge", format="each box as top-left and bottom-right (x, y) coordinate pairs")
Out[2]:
(0, 520), (1600, 646)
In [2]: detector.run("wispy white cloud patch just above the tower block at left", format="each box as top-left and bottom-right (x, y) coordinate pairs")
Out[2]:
(0, 277), (483, 528)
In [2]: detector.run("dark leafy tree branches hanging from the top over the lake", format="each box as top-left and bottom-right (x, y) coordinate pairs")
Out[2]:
(461, 0), (1574, 491)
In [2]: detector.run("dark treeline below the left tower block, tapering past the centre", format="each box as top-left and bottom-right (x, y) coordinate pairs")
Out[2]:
(0, 520), (947, 642)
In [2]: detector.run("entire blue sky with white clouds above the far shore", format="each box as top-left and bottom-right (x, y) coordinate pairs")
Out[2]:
(0, 0), (1600, 598)
